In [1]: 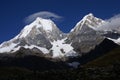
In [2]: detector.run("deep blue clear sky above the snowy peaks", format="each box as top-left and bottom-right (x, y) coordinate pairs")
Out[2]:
(0, 0), (120, 43)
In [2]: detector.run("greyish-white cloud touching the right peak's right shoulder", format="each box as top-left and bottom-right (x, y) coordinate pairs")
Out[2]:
(97, 14), (120, 31)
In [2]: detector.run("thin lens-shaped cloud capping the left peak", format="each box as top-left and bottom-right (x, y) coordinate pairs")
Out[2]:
(25, 11), (63, 23)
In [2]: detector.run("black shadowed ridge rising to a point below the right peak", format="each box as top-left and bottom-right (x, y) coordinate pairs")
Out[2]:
(80, 39), (119, 64)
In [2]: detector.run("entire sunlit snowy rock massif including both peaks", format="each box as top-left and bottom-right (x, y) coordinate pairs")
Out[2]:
(0, 13), (119, 59)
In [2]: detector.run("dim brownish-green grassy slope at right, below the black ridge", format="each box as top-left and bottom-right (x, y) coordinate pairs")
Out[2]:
(84, 47), (120, 67)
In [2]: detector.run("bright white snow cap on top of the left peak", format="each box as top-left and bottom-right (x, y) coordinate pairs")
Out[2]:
(19, 17), (56, 38)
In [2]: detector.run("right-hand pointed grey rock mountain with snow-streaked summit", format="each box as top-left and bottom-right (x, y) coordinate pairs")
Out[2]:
(68, 13), (104, 53)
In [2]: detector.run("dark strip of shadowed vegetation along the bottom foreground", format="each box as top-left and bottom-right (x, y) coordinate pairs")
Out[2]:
(0, 64), (120, 80)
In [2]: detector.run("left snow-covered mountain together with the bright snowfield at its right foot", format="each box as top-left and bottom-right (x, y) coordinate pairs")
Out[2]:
(0, 17), (76, 58)
